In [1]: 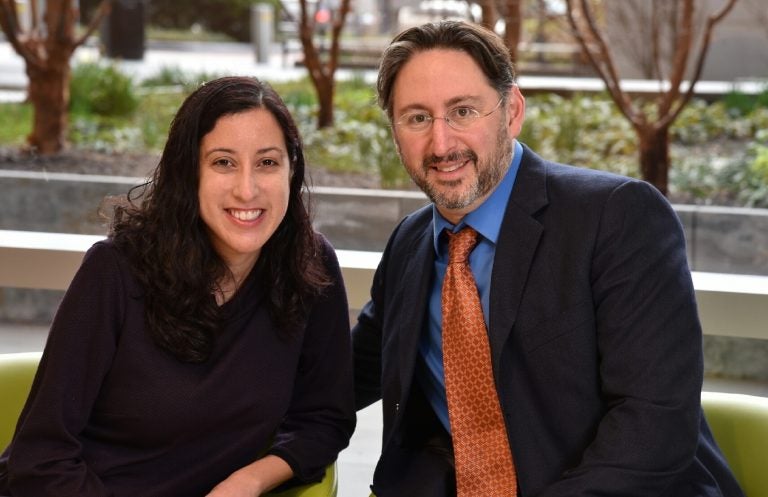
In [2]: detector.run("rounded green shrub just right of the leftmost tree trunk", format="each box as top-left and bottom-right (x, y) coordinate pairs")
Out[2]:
(69, 63), (139, 117)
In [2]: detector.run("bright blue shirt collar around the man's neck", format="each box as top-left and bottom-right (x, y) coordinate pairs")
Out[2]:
(432, 140), (523, 256)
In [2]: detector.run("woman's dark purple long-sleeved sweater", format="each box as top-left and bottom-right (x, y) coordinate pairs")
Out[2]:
(0, 237), (355, 497)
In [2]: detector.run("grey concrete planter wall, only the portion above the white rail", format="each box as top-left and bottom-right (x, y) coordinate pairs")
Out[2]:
(0, 171), (768, 275)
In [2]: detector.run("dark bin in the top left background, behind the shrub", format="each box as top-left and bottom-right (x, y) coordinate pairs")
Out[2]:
(99, 0), (146, 60)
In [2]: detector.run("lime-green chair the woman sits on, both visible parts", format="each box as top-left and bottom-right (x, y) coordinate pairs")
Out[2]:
(0, 352), (338, 497)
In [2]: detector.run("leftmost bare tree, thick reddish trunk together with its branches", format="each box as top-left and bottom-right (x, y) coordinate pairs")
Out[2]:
(0, 0), (110, 154)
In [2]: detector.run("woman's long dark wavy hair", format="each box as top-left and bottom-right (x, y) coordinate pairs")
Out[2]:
(111, 77), (328, 362)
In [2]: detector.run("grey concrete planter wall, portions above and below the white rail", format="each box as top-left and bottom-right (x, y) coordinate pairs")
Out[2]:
(0, 171), (768, 381)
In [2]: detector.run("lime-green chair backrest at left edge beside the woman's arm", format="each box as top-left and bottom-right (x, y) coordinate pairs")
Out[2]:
(0, 352), (41, 451)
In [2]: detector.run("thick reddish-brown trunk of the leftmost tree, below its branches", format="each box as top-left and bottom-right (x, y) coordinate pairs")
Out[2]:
(27, 54), (70, 154)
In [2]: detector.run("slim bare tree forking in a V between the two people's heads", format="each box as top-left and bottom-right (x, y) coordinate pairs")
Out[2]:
(298, 0), (350, 128)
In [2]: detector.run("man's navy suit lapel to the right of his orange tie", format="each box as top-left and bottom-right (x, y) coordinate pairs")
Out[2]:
(489, 147), (548, 377)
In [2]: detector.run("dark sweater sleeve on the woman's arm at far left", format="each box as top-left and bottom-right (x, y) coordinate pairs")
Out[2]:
(0, 242), (126, 497)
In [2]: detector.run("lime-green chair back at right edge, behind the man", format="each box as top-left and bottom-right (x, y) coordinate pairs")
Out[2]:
(701, 392), (768, 497)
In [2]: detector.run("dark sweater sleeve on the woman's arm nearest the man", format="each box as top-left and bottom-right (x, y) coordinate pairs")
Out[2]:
(270, 234), (355, 481)
